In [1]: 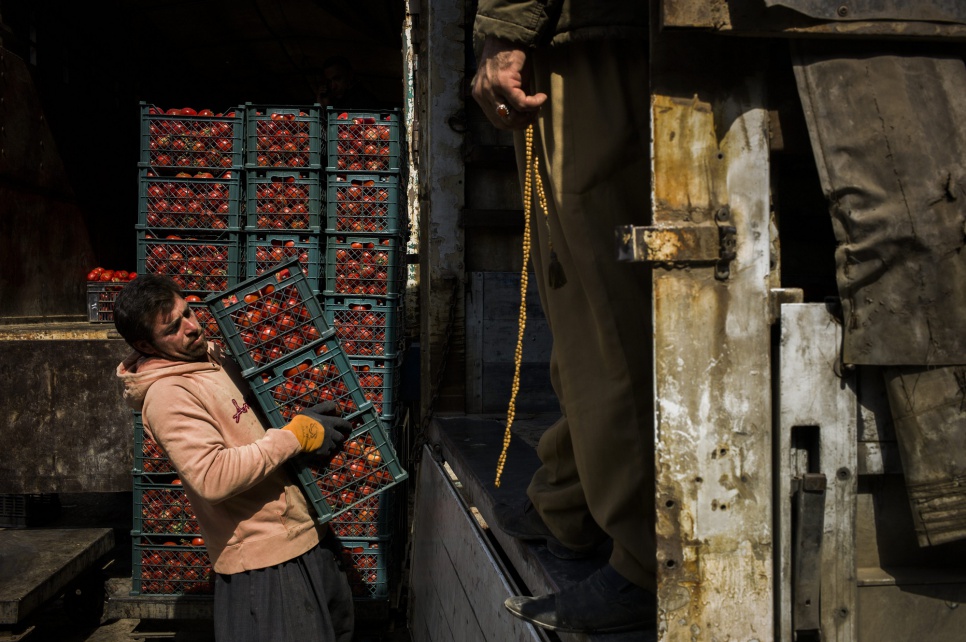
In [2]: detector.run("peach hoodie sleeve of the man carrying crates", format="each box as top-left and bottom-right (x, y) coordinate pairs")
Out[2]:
(142, 377), (301, 504)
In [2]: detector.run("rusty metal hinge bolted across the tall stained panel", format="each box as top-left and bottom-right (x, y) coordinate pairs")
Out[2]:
(616, 205), (738, 280)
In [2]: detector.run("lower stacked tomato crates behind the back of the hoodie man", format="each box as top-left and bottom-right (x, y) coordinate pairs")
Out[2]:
(131, 412), (214, 596)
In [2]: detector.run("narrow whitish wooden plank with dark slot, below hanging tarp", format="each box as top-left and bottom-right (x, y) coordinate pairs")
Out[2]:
(776, 304), (859, 642)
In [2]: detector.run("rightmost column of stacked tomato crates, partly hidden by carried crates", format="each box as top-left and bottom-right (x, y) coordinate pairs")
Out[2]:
(322, 107), (406, 597)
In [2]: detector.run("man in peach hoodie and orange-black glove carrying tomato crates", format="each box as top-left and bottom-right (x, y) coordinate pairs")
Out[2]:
(114, 275), (354, 642)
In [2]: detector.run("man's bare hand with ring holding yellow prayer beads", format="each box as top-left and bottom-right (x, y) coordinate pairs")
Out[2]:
(473, 36), (547, 129)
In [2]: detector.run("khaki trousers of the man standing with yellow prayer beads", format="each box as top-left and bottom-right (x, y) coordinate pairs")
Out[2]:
(516, 37), (655, 589)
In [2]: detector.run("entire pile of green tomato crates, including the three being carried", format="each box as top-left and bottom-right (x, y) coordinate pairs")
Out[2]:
(133, 103), (406, 601)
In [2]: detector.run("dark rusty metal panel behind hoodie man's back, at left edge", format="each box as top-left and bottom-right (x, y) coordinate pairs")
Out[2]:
(0, 339), (134, 493)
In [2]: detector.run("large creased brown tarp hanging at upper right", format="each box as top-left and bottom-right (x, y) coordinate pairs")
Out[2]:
(793, 41), (966, 365)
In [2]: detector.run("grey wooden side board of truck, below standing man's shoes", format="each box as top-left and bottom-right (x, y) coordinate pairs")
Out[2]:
(411, 448), (544, 642)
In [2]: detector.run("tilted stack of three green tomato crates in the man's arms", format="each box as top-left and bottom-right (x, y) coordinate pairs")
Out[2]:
(206, 260), (407, 600)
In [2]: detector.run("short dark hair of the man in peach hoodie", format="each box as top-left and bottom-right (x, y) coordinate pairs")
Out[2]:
(114, 274), (181, 347)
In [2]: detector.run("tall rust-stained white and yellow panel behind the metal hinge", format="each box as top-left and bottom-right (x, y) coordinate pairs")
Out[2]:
(651, 32), (774, 642)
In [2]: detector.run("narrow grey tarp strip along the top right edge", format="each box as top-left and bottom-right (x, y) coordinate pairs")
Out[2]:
(765, 0), (966, 23)
